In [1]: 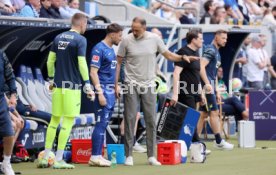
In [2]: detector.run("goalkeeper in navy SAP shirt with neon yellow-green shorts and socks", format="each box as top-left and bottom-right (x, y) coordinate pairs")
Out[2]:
(37, 13), (94, 169)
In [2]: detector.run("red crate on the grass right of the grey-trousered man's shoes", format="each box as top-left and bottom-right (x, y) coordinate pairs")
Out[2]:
(157, 143), (181, 165)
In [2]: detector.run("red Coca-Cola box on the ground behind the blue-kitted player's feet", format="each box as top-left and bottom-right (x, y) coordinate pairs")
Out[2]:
(71, 139), (104, 163)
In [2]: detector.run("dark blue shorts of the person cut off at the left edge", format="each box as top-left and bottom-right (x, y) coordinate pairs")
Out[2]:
(0, 97), (14, 137)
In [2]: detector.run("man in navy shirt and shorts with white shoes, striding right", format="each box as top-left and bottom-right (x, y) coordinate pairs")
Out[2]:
(199, 30), (234, 150)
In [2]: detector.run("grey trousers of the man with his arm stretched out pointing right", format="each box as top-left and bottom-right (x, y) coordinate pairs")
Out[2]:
(124, 84), (156, 157)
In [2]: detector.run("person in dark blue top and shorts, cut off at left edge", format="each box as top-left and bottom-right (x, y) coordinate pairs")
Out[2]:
(0, 50), (17, 175)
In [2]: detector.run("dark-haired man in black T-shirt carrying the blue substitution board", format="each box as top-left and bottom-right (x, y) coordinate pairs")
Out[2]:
(171, 29), (203, 142)
